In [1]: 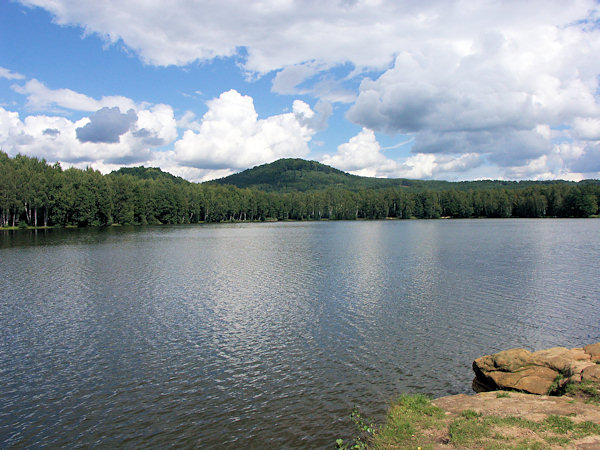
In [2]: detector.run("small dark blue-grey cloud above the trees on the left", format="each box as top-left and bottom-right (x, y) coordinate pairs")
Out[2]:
(75, 107), (137, 144)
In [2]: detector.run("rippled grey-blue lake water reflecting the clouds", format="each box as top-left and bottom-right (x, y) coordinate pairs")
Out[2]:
(0, 219), (600, 448)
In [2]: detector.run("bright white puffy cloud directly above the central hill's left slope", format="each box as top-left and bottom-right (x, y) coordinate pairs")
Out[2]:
(175, 90), (318, 169)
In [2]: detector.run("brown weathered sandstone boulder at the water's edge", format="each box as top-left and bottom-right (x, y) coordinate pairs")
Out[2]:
(473, 342), (600, 395)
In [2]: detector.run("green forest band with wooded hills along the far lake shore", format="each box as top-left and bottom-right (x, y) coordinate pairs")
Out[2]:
(0, 152), (600, 227)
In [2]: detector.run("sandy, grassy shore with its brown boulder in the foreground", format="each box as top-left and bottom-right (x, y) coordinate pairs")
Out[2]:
(360, 342), (600, 449)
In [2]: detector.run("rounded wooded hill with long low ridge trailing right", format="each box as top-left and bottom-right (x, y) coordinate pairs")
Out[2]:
(208, 158), (598, 193)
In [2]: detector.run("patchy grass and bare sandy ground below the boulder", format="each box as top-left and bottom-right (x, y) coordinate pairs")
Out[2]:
(344, 394), (600, 450)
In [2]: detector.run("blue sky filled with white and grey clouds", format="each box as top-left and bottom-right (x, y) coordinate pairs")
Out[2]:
(0, 0), (600, 182)
